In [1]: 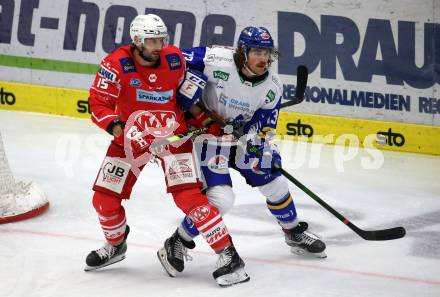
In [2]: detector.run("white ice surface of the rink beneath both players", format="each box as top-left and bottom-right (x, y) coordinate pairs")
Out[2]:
(0, 111), (440, 297)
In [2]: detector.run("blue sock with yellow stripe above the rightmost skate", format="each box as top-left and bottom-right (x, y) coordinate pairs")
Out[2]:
(266, 193), (298, 229)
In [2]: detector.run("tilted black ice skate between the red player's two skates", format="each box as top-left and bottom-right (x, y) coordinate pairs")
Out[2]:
(157, 230), (196, 277)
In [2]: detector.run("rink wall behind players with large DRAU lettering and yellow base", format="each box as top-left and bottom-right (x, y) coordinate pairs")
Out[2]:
(0, 0), (440, 154)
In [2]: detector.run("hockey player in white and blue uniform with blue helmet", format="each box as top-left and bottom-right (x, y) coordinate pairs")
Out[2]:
(158, 27), (326, 286)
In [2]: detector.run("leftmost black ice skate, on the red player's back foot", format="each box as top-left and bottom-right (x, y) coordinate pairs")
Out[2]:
(84, 225), (130, 271)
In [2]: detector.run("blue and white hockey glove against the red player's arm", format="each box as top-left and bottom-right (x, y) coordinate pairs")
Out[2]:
(176, 69), (208, 110)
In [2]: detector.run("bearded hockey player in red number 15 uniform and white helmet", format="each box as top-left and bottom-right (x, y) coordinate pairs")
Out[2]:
(85, 14), (248, 280)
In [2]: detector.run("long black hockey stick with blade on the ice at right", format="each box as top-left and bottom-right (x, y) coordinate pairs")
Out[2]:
(198, 104), (406, 240)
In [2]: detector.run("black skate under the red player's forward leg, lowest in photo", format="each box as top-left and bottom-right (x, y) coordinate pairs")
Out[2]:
(212, 245), (250, 287)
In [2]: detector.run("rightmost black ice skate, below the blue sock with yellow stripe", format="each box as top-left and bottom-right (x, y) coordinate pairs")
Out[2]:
(283, 222), (327, 258)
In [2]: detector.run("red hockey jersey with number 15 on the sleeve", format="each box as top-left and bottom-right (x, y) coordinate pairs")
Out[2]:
(90, 45), (187, 145)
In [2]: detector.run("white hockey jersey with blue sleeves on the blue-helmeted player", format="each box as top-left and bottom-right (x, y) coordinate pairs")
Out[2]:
(182, 46), (283, 134)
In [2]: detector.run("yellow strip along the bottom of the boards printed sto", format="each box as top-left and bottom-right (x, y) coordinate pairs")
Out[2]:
(0, 82), (440, 155)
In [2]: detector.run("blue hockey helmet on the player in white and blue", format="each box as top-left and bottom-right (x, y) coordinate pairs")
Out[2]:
(238, 27), (274, 50)
